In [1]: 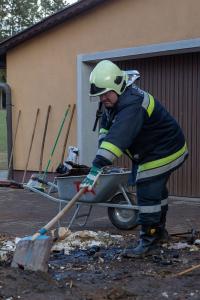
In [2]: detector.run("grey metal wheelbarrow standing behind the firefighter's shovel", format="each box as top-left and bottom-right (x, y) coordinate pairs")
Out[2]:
(24, 168), (138, 230)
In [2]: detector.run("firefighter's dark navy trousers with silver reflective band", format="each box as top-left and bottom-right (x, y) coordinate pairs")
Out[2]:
(136, 174), (170, 226)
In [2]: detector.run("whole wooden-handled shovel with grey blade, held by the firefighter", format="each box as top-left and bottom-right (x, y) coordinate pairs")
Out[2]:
(11, 188), (86, 272)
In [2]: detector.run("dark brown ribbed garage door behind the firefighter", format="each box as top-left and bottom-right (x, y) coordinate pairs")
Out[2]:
(117, 53), (200, 197)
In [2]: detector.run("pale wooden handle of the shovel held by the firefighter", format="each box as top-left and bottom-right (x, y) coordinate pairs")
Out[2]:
(32, 188), (85, 240)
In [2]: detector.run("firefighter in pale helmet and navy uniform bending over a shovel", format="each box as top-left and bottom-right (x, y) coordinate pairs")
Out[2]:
(81, 60), (188, 257)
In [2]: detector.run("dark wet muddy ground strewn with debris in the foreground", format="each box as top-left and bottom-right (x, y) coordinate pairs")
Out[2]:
(0, 234), (200, 300)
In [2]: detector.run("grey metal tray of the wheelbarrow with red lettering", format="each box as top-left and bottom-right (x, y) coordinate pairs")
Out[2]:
(56, 171), (131, 203)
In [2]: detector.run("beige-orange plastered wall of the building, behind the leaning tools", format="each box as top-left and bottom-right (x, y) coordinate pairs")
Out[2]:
(7, 0), (200, 170)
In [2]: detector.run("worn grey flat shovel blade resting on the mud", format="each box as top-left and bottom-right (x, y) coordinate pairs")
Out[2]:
(11, 235), (52, 272)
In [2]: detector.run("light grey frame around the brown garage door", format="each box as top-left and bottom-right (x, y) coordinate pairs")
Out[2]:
(77, 38), (200, 166)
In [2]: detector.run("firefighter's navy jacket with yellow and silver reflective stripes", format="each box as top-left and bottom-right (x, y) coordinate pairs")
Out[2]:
(93, 86), (188, 181)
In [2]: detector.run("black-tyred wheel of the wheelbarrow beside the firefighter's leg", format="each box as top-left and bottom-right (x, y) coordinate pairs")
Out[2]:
(108, 193), (138, 230)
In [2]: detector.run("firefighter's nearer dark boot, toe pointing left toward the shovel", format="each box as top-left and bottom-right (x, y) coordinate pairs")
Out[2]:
(122, 225), (160, 258)
